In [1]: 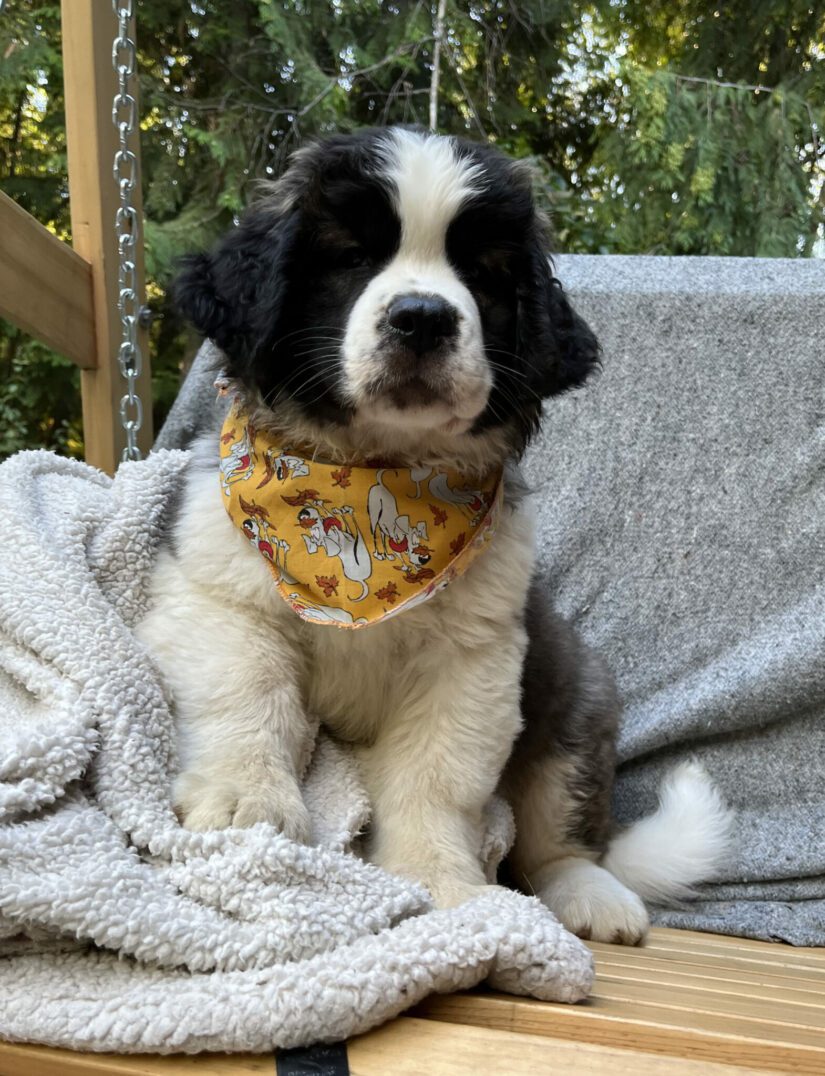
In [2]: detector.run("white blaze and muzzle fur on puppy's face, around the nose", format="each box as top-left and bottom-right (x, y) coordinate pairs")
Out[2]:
(341, 130), (493, 434)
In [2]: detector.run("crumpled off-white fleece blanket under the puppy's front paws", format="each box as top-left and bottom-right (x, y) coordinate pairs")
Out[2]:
(0, 451), (593, 1052)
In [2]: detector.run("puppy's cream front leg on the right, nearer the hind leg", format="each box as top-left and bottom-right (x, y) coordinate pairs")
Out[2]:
(359, 627), (526, 907)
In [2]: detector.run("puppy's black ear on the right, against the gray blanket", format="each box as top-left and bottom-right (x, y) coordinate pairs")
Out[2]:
(518, 240), (600, 397)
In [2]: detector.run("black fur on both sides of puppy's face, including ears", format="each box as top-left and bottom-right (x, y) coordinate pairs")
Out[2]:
(175, 128), (598, 452)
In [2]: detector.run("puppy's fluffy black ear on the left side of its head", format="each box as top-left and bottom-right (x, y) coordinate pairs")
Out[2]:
(173, 206), (299, 373)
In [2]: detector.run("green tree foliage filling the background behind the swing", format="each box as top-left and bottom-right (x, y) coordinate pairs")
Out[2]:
(0, 0), (825, 455)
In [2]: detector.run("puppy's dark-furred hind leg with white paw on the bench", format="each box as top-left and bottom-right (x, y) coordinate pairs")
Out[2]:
(502, 594), (648, 945)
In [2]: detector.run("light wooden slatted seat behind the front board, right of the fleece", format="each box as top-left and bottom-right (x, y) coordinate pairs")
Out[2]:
(416, 930), (825, 1074)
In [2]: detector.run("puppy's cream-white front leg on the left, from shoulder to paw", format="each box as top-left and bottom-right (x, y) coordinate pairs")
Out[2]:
(138, 488), (313, 840)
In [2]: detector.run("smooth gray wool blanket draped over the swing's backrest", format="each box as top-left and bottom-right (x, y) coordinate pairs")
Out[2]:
(160, 257), (825, 945)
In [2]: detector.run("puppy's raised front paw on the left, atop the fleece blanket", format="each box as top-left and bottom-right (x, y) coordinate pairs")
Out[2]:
(174, 770), (311, 843)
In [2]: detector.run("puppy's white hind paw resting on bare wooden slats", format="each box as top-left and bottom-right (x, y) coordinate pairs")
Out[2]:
(535, 856), (650, 945)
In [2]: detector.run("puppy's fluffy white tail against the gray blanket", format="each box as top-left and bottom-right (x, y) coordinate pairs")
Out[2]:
(601, 762), (734, 904)
